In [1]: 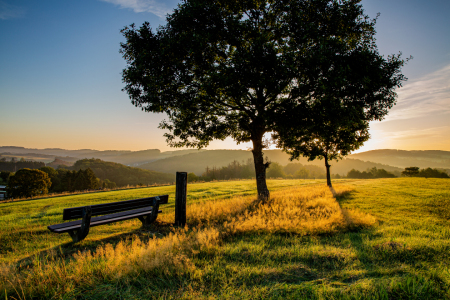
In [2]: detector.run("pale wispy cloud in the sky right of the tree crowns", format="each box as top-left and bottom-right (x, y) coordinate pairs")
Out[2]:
(386, 65), (450, 121)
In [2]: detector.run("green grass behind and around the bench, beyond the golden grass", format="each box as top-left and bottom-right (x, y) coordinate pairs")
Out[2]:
(0, 180), (321, 264)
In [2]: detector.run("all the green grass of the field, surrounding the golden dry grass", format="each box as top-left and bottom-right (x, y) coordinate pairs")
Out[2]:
(0, 178), (450, 299)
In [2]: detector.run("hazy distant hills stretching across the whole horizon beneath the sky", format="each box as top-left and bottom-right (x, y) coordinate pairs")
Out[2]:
(4, 146), (450, 175)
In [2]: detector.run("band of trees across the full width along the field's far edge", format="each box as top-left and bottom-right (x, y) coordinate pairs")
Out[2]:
(0, 159), (450, 198)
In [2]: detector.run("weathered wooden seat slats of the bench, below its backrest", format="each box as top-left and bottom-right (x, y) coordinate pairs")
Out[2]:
(47, 206), (162, 233)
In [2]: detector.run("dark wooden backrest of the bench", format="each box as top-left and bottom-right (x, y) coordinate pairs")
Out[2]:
(63, 195), (169, 220)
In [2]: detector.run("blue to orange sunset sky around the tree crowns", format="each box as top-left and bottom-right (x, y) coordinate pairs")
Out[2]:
(0, 0), (450, 152)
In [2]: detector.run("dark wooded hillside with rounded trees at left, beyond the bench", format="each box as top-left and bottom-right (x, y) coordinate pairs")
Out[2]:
(0, 159), (175, 198)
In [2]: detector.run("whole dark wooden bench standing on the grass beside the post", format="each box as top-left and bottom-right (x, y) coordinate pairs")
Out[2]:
(47, 195), (169, 243)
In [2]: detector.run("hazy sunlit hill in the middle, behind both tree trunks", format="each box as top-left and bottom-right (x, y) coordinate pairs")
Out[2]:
(139, 150), (403, 175)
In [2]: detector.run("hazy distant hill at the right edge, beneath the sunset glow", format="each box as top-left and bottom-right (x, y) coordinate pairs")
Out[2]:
(349, 149), (450, 169)
